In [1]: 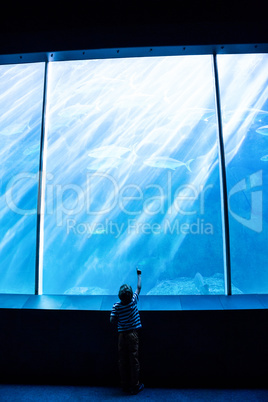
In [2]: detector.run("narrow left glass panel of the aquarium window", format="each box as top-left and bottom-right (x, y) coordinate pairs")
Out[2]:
(0, 63), (44, 293)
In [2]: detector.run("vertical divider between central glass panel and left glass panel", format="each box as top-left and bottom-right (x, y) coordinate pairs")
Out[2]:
(35, 61), (48, 295)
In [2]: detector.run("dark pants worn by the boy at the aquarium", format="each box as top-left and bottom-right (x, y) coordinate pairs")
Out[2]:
(118, 330), (140, 389)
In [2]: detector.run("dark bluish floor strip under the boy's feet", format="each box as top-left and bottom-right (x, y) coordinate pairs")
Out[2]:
(0, 385), (268, 402)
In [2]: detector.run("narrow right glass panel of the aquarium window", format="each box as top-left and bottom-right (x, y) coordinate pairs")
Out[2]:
(218, 54), (268, 293)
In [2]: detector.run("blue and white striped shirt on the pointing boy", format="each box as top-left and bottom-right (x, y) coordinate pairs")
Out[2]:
(111, 292), (141, 332)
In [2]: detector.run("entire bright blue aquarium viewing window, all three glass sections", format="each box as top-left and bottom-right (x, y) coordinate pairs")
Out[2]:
(0, 46), (268, 296)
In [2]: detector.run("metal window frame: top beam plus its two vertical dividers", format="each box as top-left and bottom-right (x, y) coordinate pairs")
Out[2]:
(0, 43), (268, 295)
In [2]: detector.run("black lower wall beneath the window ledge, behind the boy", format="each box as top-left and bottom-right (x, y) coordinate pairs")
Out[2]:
(0, 309), (268, 387)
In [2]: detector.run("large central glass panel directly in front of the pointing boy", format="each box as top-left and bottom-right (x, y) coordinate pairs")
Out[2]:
(43, 56), (224, 295)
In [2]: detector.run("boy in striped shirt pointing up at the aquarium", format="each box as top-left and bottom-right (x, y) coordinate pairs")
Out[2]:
(110, 268), (144, 394)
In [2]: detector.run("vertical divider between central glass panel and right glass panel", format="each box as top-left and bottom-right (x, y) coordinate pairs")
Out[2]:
(213, 53), (232, 295)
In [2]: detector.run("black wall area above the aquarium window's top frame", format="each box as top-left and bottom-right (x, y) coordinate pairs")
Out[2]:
(0, 0), (268, 54)
